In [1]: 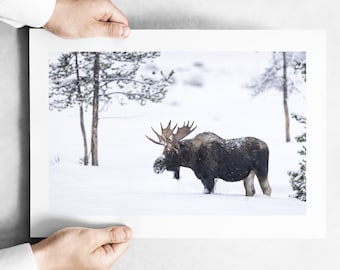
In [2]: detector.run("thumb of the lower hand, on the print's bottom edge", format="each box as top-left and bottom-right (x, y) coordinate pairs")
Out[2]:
(94, 226), (132, 248)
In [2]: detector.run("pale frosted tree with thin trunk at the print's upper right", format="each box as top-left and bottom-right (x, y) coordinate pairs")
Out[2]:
(248, 52), (306, 142)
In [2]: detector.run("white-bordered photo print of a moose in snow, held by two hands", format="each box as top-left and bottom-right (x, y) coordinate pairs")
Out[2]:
(31, 31), (324, 237)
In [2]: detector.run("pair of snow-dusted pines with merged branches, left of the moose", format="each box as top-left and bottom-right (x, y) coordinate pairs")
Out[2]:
(49, 52), (173, 166)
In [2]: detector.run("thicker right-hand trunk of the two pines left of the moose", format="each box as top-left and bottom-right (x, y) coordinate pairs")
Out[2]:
(91, 52), (99, 166)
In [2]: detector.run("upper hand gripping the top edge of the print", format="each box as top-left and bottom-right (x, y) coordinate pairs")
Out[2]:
(44, 0), (130, 39)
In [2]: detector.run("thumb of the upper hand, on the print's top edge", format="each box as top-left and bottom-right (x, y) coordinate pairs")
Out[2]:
(93, 21), (131, 38)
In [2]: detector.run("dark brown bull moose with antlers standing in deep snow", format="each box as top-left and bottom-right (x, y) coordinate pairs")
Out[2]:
(146, 121), (271, 196)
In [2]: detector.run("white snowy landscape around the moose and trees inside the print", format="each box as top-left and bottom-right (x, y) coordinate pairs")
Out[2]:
(49, 53), (306, 216)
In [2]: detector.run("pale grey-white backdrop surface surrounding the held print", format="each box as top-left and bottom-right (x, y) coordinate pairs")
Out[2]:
(0, 0), (340, 270)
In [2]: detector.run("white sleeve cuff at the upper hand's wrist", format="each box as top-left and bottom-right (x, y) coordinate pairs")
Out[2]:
(0, 0), (56, 27)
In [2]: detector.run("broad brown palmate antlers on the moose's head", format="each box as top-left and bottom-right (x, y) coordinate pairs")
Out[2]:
(145, 121), (196, 145)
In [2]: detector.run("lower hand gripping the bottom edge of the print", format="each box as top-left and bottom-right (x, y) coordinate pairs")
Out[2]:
(32, 226), (132, 270)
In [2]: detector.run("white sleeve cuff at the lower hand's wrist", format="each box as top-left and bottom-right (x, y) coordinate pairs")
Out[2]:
(0, 244), (39, 270)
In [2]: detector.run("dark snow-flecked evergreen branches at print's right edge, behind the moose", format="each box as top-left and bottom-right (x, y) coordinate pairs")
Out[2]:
(288, 114), (306, 201)
